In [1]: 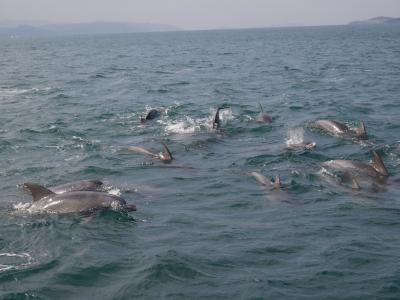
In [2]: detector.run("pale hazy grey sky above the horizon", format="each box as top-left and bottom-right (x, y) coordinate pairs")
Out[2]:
(0, 0), (400, 29)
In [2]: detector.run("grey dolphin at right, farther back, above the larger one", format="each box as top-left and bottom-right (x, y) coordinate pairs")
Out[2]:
(313, 120), (367, 140)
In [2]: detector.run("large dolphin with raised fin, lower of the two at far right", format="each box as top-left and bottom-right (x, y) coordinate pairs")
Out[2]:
(322, 151), (389, 180)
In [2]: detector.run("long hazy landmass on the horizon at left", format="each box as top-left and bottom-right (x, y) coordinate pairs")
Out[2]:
(0, 22), (181, 37)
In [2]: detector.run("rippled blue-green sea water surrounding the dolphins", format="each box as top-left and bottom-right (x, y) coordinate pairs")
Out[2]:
(0, 26), (400, 299)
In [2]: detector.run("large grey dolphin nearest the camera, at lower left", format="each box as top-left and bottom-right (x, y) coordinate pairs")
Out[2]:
(23, 183), (136, 214)
